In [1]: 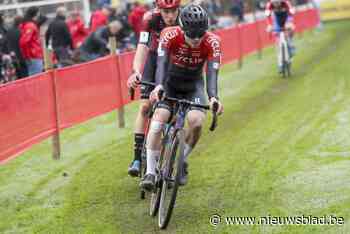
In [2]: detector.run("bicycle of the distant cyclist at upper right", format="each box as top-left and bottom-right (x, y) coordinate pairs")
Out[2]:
(275, 29), (292, 78)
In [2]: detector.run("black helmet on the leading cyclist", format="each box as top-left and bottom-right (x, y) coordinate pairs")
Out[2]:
(179, 4), (209, 38)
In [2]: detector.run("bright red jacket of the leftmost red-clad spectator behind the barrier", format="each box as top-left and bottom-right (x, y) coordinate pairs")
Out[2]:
(19, 21), (43, 59)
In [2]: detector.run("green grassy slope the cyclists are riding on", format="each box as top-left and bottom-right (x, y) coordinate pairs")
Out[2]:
(0, 22), (350, 233)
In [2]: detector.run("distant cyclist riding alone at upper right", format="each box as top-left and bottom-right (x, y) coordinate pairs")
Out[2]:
(265, 0), (295, 71)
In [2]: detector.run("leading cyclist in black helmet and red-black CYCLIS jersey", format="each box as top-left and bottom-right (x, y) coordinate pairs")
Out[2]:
(140, 4), (223, 190)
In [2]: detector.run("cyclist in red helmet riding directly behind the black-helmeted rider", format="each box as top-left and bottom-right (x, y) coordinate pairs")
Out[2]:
(128, 0), (181, 176)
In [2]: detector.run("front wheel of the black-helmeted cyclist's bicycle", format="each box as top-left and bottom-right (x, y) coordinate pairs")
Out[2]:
(158, 130), (185, 229)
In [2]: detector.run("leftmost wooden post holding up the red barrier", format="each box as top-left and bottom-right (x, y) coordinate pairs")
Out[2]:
(43, 43), (61, 160)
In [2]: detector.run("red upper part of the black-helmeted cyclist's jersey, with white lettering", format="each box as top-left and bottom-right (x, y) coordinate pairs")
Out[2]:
(158, 26), (221, 72)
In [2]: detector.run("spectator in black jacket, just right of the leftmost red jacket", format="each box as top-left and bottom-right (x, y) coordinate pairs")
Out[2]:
(45, 7), (73, 65)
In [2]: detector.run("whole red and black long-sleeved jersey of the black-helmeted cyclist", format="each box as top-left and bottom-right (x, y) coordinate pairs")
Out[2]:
(156, 26), (221, 98)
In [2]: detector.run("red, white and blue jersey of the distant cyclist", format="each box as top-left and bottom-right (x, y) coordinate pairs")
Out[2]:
(266, 0), (294, 31)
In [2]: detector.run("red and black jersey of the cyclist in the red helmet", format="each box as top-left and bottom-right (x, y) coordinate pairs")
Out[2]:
(139, 8), (174, 52)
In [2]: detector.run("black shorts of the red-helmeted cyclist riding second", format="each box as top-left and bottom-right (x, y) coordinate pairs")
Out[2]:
(141, 51), (157, 99)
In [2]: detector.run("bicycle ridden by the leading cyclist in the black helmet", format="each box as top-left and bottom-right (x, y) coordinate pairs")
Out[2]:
(132, 81), (219, 229)
